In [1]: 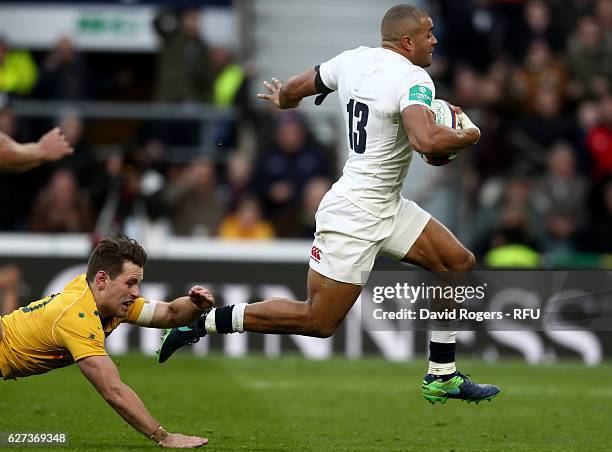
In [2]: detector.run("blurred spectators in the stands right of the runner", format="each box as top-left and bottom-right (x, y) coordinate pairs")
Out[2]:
(429, 0), (612, 266)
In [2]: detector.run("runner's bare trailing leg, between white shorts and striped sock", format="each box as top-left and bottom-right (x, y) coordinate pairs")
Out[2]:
(244, 269), (361, 337)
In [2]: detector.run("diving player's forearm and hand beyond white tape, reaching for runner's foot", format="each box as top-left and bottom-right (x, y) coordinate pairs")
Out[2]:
(148, 286), (215, 328)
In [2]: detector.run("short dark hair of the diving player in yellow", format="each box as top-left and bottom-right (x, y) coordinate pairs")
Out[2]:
(87, 235), (147, 282)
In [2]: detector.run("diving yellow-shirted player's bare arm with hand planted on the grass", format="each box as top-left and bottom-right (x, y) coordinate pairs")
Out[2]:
(77, 356), (208, 448)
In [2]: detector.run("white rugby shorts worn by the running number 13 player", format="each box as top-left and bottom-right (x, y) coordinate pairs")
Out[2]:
(310, 189), (431, 285)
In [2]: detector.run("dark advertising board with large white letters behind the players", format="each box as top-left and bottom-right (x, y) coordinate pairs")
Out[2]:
(2, 249), (612, 365)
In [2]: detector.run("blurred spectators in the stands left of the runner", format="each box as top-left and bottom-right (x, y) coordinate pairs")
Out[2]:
(0, 5), (336, 239)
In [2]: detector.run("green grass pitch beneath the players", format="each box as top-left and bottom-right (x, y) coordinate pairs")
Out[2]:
(0, 354), (612, 451)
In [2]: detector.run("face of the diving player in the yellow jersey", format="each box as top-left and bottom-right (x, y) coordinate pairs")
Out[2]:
(105, 261), (143, 317)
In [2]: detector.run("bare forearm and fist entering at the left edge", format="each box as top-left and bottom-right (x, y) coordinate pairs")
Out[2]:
(0, 127), (74, 173)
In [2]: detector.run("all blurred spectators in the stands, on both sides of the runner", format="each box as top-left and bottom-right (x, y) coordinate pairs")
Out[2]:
(0, 0), (612, 266)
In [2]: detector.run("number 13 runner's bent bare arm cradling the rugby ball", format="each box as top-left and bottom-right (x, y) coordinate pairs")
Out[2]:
(402, 105), (480, 156)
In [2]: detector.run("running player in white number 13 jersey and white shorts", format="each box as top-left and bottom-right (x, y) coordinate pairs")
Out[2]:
(159, 5), (499, 403)
